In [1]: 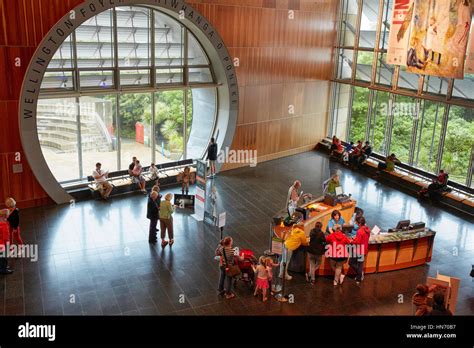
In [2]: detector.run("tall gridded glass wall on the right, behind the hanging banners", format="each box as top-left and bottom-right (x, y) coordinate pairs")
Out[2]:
(328, 0), (474, 186)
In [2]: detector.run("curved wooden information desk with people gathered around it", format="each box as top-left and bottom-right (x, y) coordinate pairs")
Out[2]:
(273, 200), (436, 275)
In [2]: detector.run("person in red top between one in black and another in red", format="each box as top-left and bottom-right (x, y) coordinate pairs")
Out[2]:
(324, 225), (351, 286)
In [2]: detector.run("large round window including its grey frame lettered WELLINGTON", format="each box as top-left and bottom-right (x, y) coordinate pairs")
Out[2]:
(20, 0), (238, 203)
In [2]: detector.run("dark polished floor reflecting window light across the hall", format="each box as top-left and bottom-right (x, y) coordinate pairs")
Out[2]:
(0, 152), (474, 315)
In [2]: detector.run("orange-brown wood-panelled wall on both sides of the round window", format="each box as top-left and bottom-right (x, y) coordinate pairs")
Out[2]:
(0, 0), (338, 207)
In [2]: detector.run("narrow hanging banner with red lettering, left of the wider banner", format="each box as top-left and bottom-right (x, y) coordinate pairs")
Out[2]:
(387, 0), (414, 66)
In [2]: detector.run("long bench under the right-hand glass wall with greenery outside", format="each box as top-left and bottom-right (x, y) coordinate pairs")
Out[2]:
(317, 138), (474, 216)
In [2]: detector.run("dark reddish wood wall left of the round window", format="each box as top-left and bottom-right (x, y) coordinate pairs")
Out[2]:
(0, 0), (79, 208)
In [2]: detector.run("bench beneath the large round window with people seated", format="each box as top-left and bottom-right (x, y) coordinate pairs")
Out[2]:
(87, 159), (196, 197)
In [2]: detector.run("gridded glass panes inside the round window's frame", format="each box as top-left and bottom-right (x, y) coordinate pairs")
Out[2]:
(37, 6), (217, 184)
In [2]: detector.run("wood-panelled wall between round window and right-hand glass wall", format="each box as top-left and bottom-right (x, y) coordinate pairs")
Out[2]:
(192, 0), (338, 170)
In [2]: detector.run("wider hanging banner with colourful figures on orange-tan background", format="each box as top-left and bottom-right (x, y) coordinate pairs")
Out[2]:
(407, 0), (471, 79)
